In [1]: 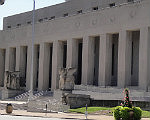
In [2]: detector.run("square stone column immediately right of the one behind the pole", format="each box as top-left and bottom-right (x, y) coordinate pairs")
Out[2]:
(38, 43), (50, 91)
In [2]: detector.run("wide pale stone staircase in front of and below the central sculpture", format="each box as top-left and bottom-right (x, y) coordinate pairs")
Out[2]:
(28, 90), (70, 112)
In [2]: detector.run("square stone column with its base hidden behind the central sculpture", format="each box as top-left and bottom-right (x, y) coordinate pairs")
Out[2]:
(67, 39), (78, 69)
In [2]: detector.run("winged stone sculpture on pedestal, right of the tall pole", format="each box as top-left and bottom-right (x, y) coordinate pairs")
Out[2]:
(59, 68), (77, 91)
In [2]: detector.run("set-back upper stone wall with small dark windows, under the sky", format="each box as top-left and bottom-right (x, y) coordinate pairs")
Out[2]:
(4, 0), (139, 29)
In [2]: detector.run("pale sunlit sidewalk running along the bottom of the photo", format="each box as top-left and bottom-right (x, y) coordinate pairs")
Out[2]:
(0, 110), (150, 120)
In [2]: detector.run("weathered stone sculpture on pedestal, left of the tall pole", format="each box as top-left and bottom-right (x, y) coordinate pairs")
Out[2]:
(4, 71), (20, 90)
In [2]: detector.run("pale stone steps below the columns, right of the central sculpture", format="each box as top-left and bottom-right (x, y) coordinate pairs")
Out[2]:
(73, 86), (150, 101)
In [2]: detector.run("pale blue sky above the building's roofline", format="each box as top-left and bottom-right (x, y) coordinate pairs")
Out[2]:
(0, 0), (65, 30)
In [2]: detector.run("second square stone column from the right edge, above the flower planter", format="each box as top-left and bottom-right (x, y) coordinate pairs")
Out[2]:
(118, 30), (132, 88)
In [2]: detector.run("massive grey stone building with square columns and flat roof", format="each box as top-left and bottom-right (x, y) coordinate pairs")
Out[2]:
(0, 0), (150, 100)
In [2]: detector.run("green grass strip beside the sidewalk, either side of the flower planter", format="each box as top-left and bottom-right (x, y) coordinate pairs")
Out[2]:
(69, 107), (150, 118)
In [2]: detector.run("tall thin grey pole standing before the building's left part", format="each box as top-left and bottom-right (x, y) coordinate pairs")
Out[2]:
(29, 0), (35, 100)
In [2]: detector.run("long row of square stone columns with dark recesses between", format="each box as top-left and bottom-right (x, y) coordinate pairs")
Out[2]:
(0, 27), (150, 90)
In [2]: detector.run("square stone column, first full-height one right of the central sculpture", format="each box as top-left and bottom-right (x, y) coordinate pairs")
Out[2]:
(81, 36), (95, 85)
